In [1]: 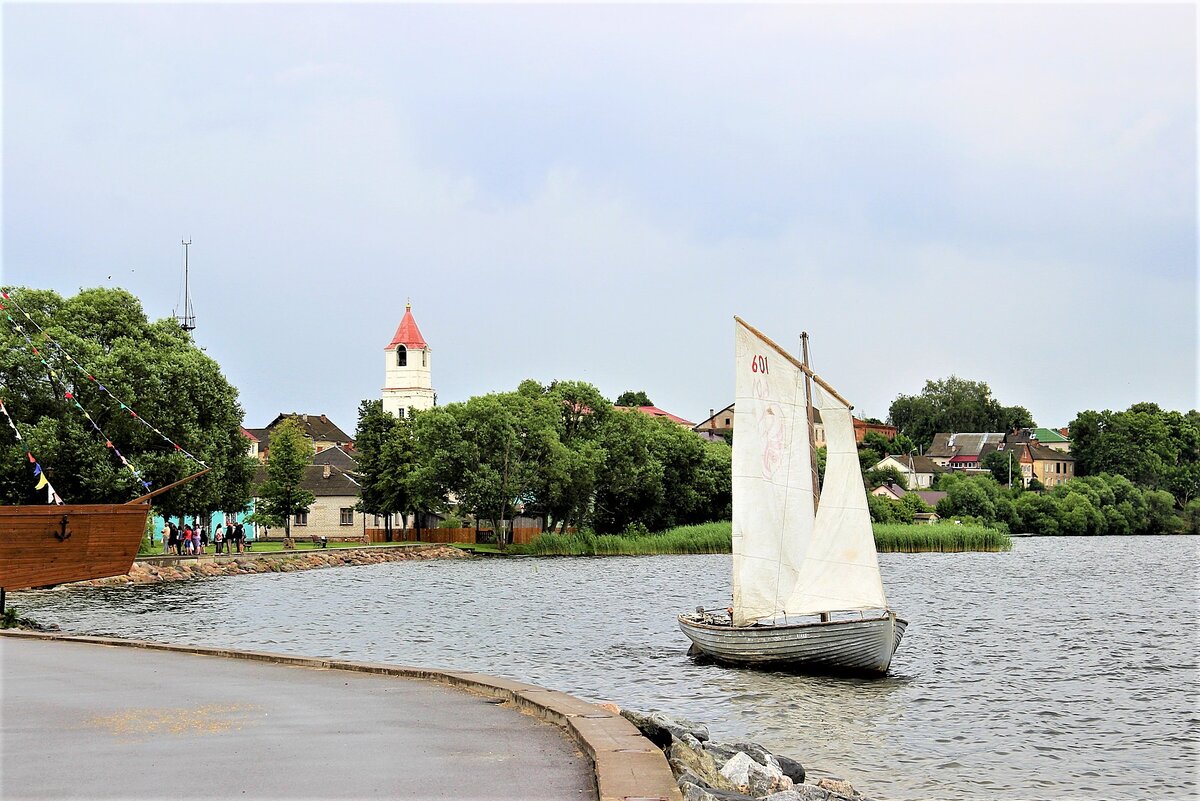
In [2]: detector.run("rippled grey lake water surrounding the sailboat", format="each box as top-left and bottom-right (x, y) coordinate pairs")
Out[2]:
(10, 537), (1200, 801)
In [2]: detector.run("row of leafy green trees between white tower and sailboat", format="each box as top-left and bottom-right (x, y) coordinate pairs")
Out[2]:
(358, 380), (732, 534)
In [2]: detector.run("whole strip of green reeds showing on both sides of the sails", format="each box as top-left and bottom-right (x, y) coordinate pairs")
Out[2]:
(505, 520), (1013, 556)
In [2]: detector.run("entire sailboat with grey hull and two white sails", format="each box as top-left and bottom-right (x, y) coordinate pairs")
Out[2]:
(678, 317), (908, 675)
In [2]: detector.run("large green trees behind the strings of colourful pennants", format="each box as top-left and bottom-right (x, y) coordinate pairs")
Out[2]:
(0, 288), (254, 517)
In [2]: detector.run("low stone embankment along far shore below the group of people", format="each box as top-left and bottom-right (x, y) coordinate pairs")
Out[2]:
(74, 546), (470, 586)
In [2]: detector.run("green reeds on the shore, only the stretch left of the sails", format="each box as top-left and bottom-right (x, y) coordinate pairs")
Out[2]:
(506, 522), (733, 556)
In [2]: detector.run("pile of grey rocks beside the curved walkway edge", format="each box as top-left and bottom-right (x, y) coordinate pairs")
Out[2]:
(620, 709), (869, 801)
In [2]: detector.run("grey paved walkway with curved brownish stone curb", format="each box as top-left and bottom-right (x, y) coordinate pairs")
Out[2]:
(0, 632), (679, 801)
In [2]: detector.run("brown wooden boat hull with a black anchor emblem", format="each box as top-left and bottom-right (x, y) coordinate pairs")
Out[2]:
(0, 504), (150, 590)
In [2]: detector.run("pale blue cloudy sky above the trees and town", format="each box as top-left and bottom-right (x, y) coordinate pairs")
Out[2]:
(0, 2), (1198, 430)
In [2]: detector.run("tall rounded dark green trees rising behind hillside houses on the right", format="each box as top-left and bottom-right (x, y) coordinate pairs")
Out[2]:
(888, 375), (1034, 448)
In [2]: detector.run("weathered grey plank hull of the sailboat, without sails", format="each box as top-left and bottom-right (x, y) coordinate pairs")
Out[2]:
(679, 612), (908, 675)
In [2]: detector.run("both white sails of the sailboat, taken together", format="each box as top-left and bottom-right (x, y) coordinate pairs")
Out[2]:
(733, 320), (887, 626)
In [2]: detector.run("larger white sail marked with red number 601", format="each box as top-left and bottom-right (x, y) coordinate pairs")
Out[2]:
(733, 321), (814, 626)
